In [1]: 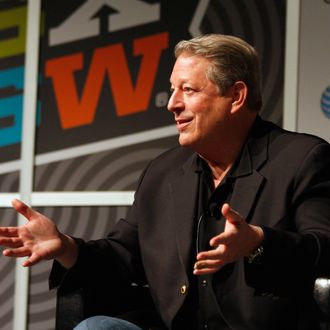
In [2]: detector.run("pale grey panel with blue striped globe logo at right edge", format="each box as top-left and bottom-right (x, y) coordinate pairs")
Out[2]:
(297, 0), (330, 142)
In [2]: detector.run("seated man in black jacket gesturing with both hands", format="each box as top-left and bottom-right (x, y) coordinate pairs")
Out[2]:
(0, 34), (330, 330)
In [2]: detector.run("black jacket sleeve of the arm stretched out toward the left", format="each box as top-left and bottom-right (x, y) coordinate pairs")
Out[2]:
(49, 165), (154, 289)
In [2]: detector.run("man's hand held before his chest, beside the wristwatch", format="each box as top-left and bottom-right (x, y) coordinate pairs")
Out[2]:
(194, 204), (264, 275)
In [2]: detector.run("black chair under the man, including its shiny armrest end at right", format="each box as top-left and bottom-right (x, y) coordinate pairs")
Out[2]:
(55, 277), (330, 330)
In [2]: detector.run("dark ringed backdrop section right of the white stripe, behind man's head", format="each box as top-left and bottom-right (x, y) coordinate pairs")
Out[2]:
(201, 0), (285, 125)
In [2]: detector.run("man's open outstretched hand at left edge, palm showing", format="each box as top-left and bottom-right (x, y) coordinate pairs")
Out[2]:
(0, 199), (78, 268)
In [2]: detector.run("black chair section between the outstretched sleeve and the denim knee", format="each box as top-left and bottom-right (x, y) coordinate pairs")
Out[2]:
(55, 285), (164, 330)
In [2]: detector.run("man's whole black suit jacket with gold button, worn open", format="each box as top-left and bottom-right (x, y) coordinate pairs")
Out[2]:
(51, 118), (330, 330)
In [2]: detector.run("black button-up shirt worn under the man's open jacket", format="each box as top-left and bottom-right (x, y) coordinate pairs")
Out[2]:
(195, 147), (250, 330)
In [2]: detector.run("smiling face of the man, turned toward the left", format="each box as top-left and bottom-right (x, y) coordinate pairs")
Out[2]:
(167, 53), (232, 151)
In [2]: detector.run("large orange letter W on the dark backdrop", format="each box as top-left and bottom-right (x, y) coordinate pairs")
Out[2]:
(46, 32), (168, 129)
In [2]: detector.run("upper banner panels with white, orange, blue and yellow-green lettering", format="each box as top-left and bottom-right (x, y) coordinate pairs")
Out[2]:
(0, 0), (201, 162)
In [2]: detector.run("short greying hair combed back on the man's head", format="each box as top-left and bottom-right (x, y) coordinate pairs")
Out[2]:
(174, 34), (262, 111)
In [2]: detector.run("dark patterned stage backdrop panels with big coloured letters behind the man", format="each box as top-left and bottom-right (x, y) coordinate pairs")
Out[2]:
(0, 0), (285, 330)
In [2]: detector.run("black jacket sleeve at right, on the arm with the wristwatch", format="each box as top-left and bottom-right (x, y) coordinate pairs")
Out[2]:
(245, 143), (330, 295)
